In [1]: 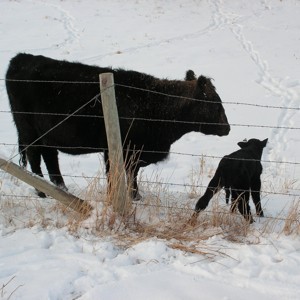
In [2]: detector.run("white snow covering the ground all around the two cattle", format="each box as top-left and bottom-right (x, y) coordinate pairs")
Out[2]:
(0, 0), (300, 300)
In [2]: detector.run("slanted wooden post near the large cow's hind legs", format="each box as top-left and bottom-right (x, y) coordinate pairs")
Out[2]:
(0, 158), (92, 215)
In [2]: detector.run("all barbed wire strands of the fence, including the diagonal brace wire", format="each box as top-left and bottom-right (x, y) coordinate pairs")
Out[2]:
(0, 79), (300, 224)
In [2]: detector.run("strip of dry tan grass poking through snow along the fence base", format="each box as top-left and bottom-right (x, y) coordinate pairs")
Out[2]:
(0, 159), (300, 256)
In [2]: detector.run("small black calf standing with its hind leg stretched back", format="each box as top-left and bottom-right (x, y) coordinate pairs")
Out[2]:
(194, 139), (268, 223)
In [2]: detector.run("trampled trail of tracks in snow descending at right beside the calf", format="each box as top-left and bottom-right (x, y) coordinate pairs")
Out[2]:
(210, 0), (299, 174)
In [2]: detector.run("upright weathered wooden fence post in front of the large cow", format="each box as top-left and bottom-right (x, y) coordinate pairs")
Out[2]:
(99, 73), (130, 215)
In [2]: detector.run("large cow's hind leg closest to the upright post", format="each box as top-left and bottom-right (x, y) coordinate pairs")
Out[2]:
(42, 148), (68, 191)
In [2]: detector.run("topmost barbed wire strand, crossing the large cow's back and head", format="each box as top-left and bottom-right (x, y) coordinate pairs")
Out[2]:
(0, 78), (300, 110)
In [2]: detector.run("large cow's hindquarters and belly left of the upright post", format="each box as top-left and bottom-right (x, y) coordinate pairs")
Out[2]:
(6, 54), (109, 154)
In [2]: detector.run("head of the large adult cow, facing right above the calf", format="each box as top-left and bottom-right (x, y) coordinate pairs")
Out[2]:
(192, 76), (230, 136)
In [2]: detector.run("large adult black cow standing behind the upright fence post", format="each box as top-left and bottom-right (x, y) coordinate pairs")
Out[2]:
(6, 54), (230, 198)
